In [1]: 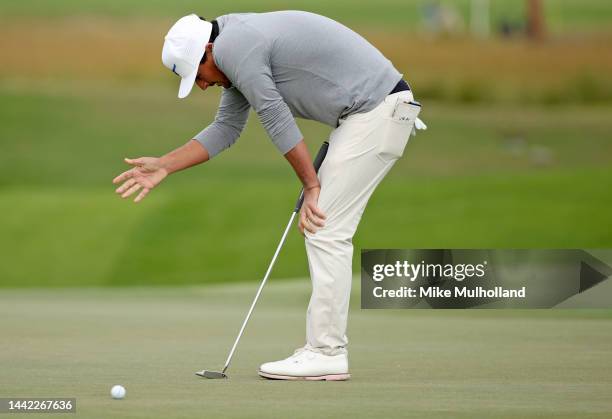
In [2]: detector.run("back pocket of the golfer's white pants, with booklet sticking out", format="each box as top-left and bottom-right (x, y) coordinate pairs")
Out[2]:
(378, 99), (421, 162)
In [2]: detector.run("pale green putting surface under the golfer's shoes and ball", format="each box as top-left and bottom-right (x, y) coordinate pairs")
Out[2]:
(0, 279), (612, 418)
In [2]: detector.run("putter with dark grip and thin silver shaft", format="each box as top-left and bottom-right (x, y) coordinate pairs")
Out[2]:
(196, 141), (329, 379)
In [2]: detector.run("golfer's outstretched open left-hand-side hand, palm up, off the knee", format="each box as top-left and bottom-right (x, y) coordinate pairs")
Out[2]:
(113, 157), (168, 202)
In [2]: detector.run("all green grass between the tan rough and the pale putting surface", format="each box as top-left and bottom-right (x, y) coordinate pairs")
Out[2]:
(0, 85), (612, 286)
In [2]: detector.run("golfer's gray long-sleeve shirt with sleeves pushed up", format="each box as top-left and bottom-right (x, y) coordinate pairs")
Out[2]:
(195, 11), (402, 157)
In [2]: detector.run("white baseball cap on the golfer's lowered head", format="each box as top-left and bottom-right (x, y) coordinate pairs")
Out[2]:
(162, 14), (212, 99)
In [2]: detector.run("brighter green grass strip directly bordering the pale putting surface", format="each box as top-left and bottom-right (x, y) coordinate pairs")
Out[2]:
(0, 171), (612, 287)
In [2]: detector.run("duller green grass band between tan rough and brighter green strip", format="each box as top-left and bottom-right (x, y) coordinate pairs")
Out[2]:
(0, 82), (612, 187)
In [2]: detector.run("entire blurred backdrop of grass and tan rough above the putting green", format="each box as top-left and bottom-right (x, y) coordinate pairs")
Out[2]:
(0, 0), (612, 287)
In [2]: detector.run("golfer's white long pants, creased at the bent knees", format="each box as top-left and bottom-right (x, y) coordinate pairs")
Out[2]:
(305, 91), (420, 355)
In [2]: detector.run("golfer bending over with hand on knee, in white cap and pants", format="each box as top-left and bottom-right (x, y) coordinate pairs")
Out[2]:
(113, 11), (420, 380)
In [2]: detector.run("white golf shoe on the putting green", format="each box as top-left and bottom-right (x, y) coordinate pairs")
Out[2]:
(259, 348), (351, 381)
